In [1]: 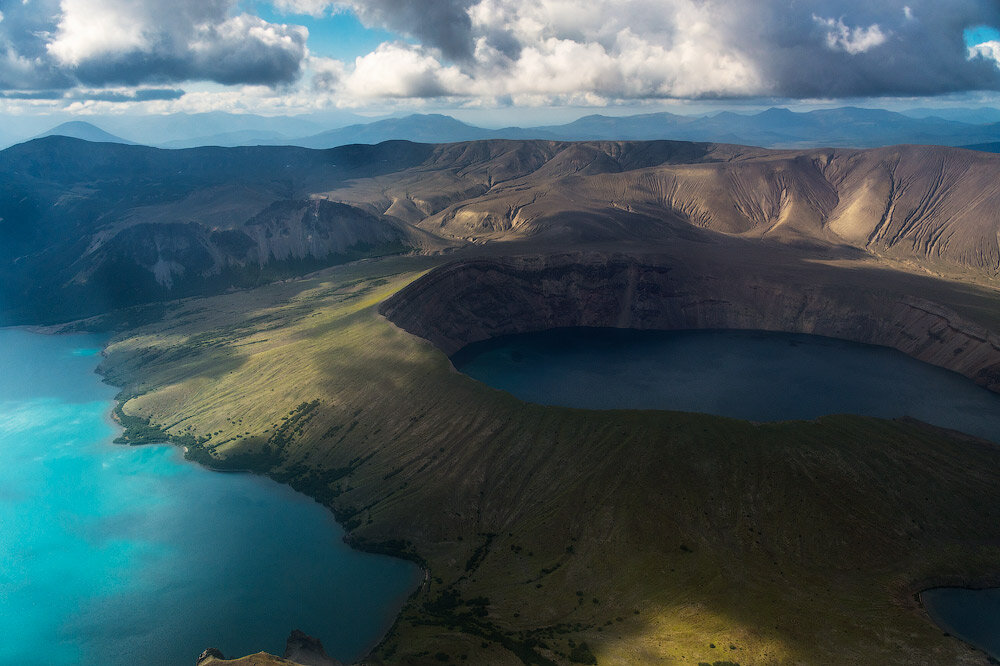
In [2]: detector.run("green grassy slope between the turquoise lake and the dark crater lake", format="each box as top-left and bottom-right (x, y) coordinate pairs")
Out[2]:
(95, 257), (1000, 664)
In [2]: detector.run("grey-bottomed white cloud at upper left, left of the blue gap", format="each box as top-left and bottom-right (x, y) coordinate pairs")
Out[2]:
(0, 0), (308, 90)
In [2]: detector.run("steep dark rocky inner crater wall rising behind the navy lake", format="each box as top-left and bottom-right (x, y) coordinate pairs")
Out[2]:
(381, 253), (1000, 392)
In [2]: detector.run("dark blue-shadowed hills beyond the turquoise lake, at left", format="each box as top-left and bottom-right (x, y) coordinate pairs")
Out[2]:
(0, 137), (440, 325)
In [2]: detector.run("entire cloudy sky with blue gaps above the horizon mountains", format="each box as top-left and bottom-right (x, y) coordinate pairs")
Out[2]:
(0, 0), (1000, 124)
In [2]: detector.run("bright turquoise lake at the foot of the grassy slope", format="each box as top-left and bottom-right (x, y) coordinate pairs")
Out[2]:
(0, 329), (420, 665)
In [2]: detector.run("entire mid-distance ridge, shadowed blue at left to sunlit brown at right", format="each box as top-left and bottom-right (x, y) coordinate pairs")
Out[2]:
(0, 132), (1000, 325)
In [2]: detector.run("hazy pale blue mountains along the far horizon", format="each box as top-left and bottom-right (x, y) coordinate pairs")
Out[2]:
(31, 107), (1000, 148)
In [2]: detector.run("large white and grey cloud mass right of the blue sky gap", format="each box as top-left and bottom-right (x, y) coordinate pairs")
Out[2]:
(316, 0), (1000, 100)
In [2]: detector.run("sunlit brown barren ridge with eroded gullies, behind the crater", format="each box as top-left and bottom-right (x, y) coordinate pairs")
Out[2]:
(329, 142), (1000, 278)
